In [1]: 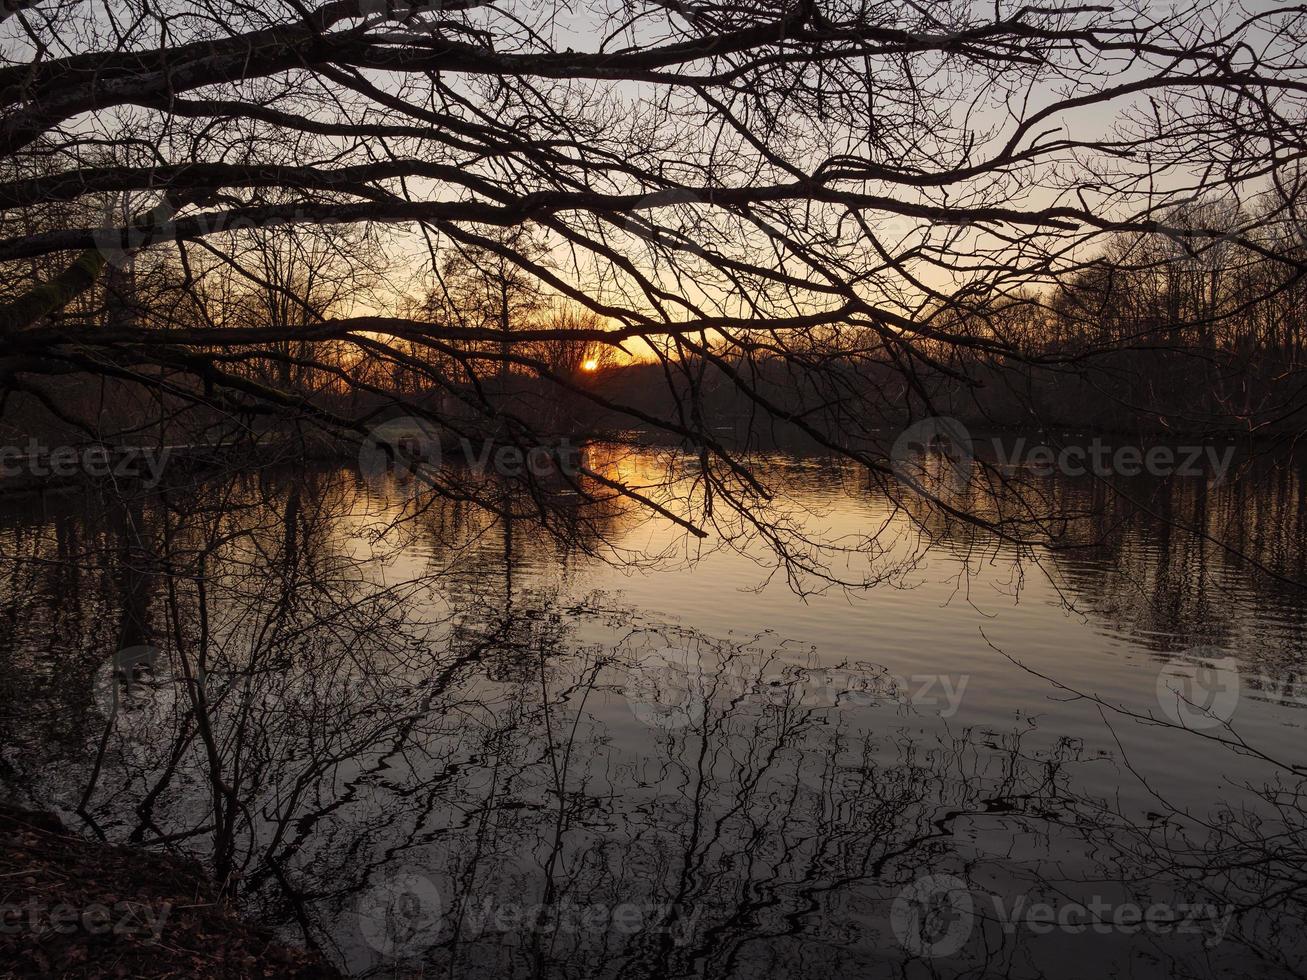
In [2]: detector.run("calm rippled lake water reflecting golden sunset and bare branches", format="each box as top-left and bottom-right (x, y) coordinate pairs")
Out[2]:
(0, 449), (1307, 977)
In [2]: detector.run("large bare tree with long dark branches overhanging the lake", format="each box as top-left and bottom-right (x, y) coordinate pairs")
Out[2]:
(0, 0), (1307, 582)
